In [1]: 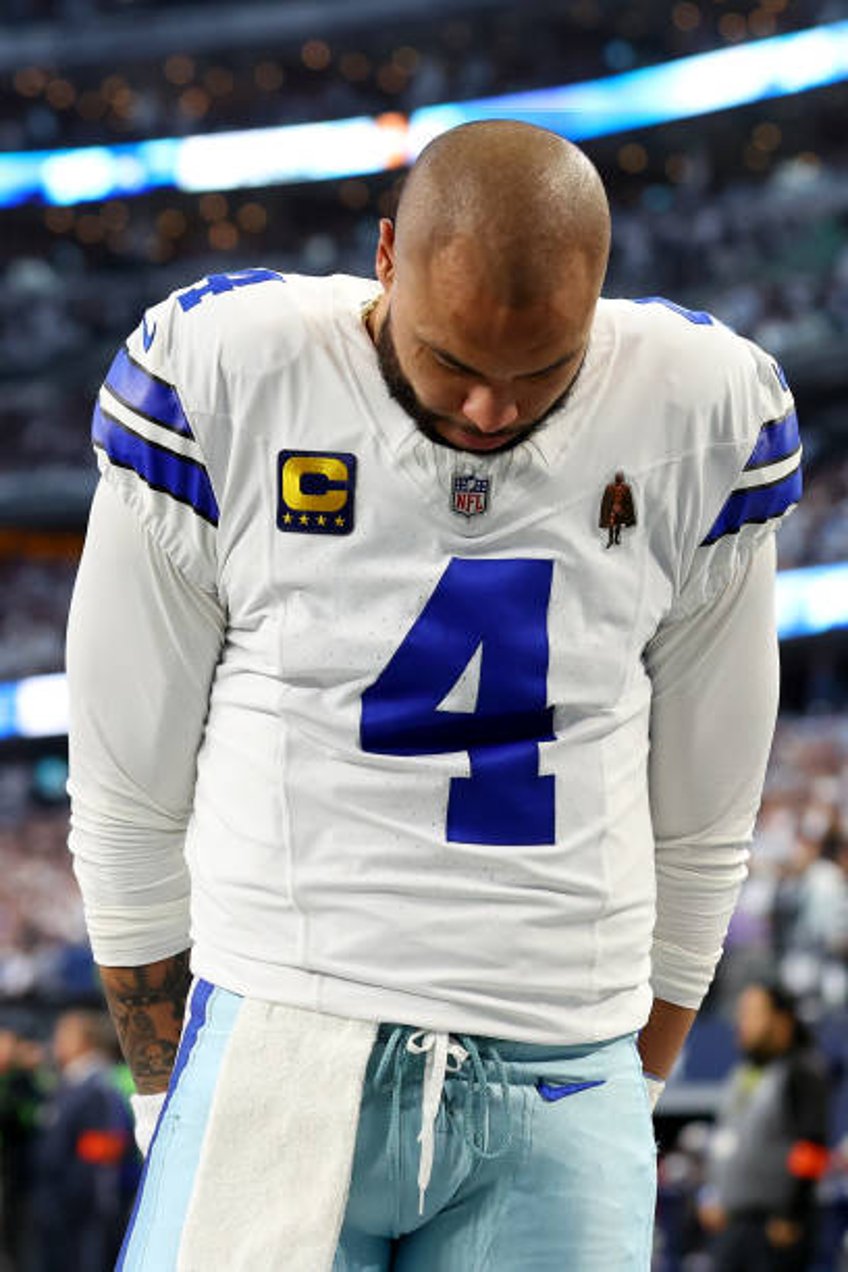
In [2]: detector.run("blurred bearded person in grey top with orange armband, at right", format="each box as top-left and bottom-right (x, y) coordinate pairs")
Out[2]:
(699, 983), (829, 1272)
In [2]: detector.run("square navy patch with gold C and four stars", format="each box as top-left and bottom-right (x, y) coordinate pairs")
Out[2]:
(277, 450), (356, 534)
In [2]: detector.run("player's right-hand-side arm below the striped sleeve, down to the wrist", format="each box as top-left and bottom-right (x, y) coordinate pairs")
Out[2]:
(639, 534), (778, 1079)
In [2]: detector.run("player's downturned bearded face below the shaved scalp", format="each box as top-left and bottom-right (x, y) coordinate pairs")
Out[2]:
(376, 223), (598, 452)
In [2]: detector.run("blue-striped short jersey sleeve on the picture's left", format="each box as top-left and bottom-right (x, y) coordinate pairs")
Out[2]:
(92, 288), (219, 591)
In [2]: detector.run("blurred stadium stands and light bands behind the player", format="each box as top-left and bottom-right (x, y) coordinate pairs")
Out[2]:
(0, 0), (848, 1272)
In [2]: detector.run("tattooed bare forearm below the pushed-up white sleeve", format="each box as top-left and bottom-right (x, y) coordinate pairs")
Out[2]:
(100, 950), (191, 1094)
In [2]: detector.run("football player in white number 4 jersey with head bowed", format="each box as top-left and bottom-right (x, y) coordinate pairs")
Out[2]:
(69, 121), (801, 1272)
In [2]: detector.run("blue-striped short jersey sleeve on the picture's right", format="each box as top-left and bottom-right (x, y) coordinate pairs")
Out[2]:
(674, 337), (802, 617)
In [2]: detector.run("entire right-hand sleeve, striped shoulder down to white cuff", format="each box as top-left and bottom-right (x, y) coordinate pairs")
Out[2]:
(645, 329), (801, 1007)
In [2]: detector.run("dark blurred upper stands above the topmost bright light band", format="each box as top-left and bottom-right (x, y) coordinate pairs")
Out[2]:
(0, 0), (843, 150)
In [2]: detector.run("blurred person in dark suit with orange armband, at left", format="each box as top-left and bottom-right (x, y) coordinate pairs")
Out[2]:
(33, 1010), (137, 1272)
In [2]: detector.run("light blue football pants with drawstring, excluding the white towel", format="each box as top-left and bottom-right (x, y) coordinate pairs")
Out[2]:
(118, 981), (656, 1272)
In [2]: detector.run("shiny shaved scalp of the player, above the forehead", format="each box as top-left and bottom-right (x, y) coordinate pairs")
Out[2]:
(395, 120), (609, 305)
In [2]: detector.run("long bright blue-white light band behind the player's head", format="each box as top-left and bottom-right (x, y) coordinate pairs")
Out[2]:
(0, 20), (848, 207)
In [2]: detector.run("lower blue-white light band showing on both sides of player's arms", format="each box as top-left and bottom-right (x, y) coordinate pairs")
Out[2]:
(0, 562), (848, 742)
